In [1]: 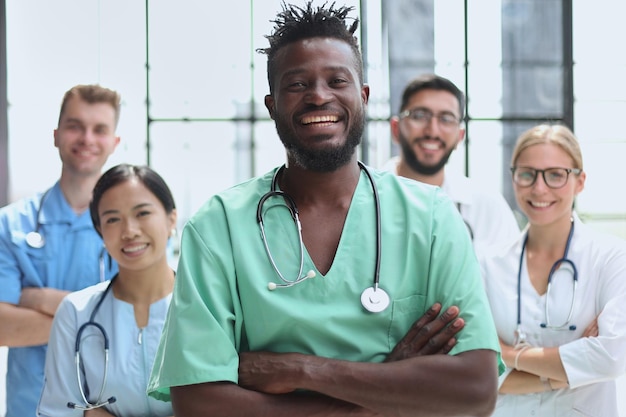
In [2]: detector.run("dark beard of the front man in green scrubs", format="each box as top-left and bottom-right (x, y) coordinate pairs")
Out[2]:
(275, 110), (365, 172)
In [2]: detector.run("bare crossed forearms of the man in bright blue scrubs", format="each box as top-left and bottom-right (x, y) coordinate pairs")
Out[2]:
(0, 288), (68, 347)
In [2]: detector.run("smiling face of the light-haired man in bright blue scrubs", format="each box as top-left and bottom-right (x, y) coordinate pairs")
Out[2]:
(54, 96), (120, 180)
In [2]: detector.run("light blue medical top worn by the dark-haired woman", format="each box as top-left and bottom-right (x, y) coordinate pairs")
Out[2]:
(38, 281), (173, 417)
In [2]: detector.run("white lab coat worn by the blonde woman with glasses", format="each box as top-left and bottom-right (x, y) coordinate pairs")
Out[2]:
(479, 215), (626, 417)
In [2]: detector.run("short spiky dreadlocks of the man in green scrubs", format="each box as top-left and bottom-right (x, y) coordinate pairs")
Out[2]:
(257, 0), (363, 92)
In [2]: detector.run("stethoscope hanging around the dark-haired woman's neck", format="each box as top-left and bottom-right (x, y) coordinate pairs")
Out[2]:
(67, 275), (117, 411)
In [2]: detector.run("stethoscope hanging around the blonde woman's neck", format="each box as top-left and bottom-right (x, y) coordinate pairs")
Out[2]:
(515, 218), (578, 347)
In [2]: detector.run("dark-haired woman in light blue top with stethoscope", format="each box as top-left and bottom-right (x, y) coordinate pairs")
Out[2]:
(38, 164), (176, 417)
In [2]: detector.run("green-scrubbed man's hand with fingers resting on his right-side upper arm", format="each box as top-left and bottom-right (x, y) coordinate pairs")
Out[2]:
(385, 303), (465, 362)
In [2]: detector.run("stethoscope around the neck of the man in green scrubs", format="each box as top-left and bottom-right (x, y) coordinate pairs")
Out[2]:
(256, 161), (389, 312)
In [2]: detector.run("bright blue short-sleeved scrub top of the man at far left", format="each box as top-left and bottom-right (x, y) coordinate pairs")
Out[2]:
(0, 182), (117, 417)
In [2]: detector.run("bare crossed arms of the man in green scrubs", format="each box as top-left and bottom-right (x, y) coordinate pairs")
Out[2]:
(170, 304), (497, 417)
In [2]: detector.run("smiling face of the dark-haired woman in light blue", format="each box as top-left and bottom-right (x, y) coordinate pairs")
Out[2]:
(98, 177), (176, 271)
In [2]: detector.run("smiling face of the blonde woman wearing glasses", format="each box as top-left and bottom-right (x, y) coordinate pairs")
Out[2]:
(513, 143), (585, 225)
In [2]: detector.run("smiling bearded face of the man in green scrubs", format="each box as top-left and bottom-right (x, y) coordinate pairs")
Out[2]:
(265, 38), (369, 172)
